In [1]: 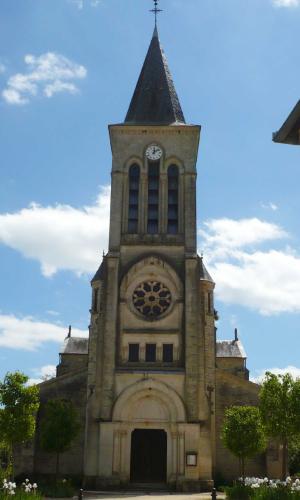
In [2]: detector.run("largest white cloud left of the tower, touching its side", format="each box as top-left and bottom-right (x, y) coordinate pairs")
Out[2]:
(0, 187), (110, 277)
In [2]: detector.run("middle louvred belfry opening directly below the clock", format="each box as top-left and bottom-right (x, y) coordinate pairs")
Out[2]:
(147, 161), (159, 234)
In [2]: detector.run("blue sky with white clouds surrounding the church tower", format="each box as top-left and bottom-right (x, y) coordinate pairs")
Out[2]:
(0, 0), (300, 379)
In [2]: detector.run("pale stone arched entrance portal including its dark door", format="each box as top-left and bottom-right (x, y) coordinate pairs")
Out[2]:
(112, 378), (186, 482)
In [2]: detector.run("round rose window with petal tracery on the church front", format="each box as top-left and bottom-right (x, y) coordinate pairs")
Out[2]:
(132, 281), (172, 318)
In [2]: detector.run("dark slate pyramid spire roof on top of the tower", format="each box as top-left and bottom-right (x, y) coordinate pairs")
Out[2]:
(125, 28), (185, 125)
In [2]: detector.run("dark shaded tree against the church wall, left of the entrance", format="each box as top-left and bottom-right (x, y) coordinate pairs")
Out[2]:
(40, 399), (80, 480)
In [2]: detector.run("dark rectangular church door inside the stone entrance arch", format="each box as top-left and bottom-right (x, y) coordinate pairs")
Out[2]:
(130, 429), (167, 483)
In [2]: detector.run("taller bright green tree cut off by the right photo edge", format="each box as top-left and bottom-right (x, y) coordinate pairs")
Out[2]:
(259, 372), (300, 479)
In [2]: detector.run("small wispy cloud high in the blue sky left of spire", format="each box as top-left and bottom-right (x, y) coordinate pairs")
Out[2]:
(2, 52), (87, 104)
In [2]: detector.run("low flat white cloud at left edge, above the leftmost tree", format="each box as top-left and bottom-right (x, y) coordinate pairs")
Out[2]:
(0, 314), (87, 351)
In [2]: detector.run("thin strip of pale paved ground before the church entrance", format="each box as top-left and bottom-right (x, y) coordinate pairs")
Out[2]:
(84, 492), (225, 500)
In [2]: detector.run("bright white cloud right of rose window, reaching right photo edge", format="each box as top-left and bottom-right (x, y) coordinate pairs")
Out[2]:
(210, 250), (300, 315)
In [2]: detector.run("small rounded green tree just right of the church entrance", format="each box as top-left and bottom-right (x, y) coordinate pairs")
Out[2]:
(221, 406), (266, 481)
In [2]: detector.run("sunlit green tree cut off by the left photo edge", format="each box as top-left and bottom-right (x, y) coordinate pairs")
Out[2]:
(0, 372), (39, 475)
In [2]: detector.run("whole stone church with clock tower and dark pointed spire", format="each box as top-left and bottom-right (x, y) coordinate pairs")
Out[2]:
(16, 25), (279, 491)
